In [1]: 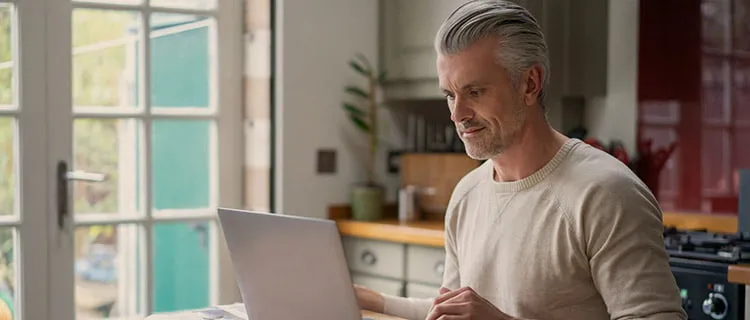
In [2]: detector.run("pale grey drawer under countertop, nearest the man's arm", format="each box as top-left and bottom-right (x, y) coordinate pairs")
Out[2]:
(406, 245), (445, 286)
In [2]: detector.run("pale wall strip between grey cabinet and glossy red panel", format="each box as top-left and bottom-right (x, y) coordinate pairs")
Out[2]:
(585, 0), (638, 154)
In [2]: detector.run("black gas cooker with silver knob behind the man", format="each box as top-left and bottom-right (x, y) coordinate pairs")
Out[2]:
(664, 228), (750, 320)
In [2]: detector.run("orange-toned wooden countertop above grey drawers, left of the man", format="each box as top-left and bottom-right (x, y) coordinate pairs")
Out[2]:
(336, 219), (445, 247)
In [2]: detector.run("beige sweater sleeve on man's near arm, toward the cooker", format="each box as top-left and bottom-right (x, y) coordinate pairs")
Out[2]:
(580, 179), (687, 320)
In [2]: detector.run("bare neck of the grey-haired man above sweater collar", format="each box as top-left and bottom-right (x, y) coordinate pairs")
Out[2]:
(492, 121), (568, 182)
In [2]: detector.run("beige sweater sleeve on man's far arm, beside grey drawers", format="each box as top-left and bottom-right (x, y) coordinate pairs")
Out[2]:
(383, 208), (460, 320)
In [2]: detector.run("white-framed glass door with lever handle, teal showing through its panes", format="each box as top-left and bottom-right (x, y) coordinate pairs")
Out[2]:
(46, 0), (242, 319)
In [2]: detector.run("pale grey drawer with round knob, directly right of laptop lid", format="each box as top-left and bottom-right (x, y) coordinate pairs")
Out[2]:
(342, 237), (404, 280)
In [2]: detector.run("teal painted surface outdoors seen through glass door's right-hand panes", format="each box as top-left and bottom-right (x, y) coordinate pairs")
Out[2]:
(149, 15), (211, 312)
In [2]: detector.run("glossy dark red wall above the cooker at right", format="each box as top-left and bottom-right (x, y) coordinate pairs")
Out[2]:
(638, 0), (750, 214)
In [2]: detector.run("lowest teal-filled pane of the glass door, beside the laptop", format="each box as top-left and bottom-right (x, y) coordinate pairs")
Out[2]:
(153, 222), (215, 312)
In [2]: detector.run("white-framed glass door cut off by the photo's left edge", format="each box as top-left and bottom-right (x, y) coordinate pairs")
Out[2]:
(0, 0), (51, 319)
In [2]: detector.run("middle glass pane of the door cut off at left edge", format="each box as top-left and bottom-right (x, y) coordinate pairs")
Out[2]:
(0, 118), (17, 215)
